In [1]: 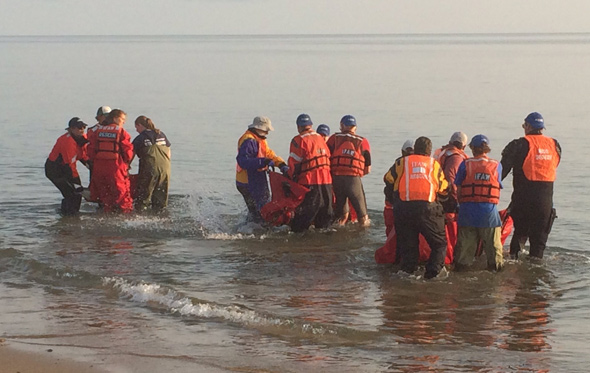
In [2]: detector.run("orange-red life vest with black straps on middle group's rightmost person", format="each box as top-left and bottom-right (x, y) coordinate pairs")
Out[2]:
(330, 133), (365, 176)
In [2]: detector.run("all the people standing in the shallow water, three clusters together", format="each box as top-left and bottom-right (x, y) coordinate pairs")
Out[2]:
(45, 106), (561, 279)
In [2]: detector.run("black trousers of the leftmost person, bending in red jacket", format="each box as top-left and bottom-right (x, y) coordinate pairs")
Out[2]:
(45, 160), (82, 215)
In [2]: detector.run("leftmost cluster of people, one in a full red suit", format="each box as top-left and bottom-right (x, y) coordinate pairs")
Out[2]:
(45, 106), (170, 215)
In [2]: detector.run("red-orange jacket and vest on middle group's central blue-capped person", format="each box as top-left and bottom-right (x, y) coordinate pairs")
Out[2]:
(291, 131), (332, 185)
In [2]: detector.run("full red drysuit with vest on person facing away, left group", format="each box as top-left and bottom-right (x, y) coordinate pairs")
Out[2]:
(89, 124), (133, 212)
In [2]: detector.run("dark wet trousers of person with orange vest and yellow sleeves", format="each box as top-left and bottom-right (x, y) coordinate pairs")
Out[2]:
(393, 201), (447, 278)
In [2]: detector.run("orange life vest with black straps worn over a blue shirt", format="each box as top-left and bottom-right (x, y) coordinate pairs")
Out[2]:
(459, 156), (500, 204)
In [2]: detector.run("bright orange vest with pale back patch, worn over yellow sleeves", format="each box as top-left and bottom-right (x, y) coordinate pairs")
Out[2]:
(398, 154), (438, 202)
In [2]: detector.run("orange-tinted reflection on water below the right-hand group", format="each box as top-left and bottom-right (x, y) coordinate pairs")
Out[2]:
(379, 262), (553, 371)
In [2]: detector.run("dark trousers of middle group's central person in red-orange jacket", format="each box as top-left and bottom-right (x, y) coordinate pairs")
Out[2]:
(291, 184), (334, 232)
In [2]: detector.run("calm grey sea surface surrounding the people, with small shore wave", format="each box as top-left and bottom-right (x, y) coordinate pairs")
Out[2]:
(0, 34), (590, 372)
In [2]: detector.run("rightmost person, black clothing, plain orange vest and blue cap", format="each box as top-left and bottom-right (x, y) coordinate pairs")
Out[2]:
(501, 112), (561, 259)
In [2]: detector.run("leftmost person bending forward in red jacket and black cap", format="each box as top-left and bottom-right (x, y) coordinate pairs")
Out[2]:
(45, 117), (88, 216)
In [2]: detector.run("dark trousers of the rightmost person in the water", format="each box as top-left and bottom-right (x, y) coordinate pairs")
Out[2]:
(510, 194), (555, 259)
